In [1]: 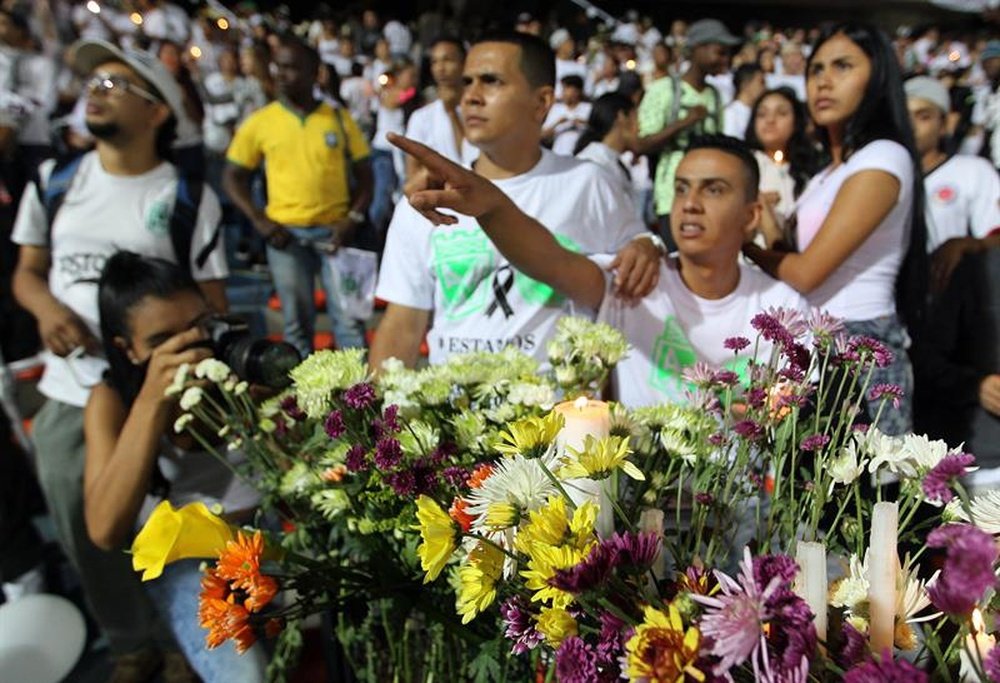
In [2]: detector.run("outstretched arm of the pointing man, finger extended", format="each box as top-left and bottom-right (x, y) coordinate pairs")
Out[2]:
(389, 134), (605, 309)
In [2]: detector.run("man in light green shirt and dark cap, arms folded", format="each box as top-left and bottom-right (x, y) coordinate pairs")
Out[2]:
(637, 19), (740, 250)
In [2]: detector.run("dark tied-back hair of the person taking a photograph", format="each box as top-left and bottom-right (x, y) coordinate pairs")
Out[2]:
(97, 251), (201, 407)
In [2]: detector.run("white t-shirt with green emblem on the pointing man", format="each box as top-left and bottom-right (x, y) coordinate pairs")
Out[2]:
(598, 258), (809, 408)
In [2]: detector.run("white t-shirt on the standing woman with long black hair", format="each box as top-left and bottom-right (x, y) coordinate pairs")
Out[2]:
(797, 140), (913, 320)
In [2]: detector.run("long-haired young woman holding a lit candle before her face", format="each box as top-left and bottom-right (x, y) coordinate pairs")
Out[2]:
(744, 88), (819, 236)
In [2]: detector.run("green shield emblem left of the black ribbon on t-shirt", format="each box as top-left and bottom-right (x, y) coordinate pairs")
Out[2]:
(431, 227), (497, 320)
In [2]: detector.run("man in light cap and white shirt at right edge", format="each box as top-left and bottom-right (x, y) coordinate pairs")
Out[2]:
(904, 76), (1000, 291)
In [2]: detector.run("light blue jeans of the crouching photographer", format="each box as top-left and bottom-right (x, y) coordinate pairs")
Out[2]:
(143, 560), (267, 683)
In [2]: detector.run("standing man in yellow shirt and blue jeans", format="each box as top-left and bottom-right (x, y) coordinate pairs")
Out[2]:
(223, 39), (372, 356)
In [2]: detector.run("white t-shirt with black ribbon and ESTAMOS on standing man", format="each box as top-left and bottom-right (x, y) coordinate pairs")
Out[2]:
(375, 150), (643, 363)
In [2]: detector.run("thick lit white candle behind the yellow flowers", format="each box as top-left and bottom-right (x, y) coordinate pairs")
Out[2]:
(553, 396), (615, 538)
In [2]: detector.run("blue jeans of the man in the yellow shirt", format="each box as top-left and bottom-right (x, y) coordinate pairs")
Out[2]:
(267, 226), (365, 358)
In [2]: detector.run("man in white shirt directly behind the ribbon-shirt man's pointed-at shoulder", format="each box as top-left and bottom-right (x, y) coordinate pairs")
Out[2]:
(406, 37), (479, 181)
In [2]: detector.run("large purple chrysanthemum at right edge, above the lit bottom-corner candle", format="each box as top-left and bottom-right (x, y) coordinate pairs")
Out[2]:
(927, 524), (997, 615)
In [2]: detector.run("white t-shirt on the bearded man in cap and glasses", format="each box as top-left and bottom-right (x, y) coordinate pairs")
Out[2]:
(11, 151), (228, 408)
